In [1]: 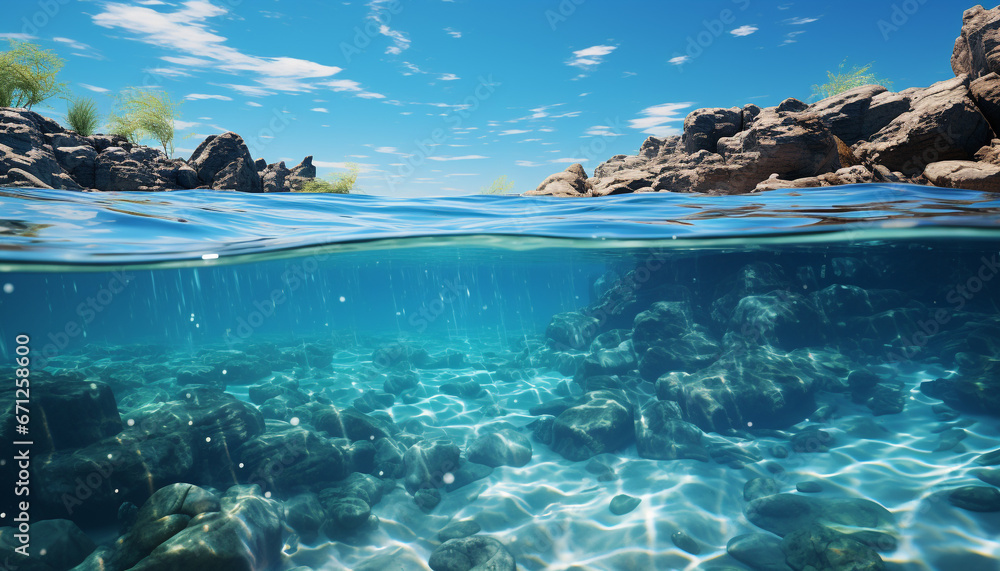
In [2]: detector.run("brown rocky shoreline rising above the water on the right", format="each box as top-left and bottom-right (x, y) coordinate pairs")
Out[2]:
(527, 6), (1000, 197)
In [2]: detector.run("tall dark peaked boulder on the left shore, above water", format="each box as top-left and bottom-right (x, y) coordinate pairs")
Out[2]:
(188, 132), (264, 192)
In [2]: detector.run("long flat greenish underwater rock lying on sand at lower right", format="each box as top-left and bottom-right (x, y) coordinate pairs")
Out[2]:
(746, 494), (896, 551)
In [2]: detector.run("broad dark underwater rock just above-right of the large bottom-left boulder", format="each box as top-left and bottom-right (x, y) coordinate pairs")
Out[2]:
(233, 425), (351, 492)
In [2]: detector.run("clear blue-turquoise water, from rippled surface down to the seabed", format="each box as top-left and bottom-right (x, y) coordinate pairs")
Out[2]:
(0, 185), (1000, 571)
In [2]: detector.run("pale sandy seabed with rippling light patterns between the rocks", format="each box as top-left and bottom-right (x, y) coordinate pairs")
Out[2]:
(219, 340), (1000, 571)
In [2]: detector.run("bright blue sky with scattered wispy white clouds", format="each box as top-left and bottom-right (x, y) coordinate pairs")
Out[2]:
(0, 0), (970, 196)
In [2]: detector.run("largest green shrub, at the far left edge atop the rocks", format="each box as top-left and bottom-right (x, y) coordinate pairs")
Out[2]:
(0, 40), (66, 109)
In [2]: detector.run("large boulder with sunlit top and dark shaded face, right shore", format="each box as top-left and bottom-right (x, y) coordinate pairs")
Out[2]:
(854, 75), (994, 175)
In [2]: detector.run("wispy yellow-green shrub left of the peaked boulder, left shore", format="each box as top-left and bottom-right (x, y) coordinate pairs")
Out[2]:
(108, 87), (180, 156)
